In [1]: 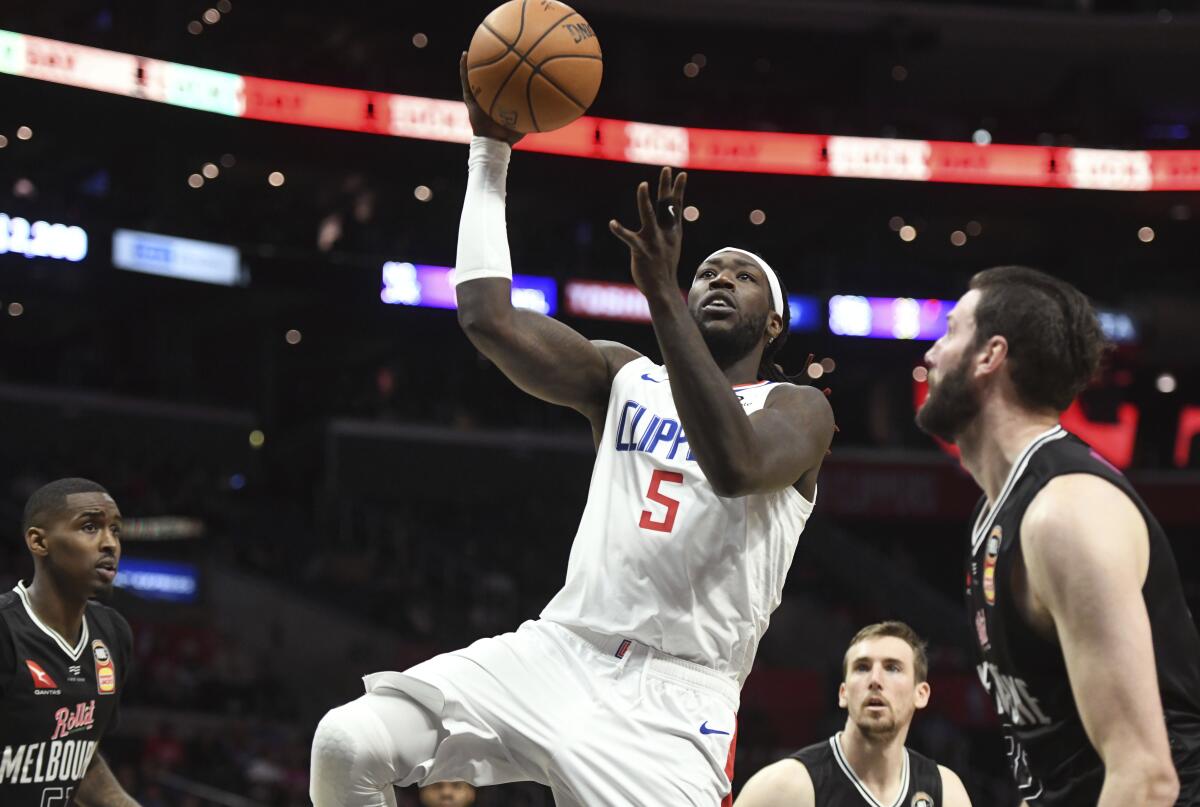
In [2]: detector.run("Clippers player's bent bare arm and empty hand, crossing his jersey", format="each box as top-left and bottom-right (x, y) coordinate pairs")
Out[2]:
(608, 168), (834, 497)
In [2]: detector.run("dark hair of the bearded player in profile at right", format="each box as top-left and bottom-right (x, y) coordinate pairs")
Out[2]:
(971, 267), (1106, 412)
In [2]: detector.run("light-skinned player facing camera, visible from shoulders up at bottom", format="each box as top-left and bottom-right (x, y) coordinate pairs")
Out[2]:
(734, 622), (971, 807)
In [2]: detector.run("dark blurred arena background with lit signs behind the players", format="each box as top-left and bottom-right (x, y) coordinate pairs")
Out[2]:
(0, 0), (1200, 807)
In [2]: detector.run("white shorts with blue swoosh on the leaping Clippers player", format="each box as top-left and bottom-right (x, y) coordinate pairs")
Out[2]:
(364, 620), (739, 807)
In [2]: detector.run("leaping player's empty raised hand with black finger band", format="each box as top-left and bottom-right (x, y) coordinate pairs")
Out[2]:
(608, 167), (688, 297)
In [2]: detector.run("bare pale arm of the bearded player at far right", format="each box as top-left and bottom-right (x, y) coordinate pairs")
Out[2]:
(1021, 474), (1180, 807)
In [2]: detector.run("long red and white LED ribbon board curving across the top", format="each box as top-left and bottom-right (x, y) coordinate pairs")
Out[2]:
(0, 31), (1200, 191)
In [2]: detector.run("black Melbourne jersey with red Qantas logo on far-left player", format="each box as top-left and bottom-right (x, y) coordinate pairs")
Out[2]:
(0, 582), (133, 807)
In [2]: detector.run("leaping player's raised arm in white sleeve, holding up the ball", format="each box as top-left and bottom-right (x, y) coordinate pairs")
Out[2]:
(455, 54), (638, 429)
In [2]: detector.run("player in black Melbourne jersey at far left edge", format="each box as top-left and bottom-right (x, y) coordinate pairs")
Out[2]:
(0, 479), (138, 807)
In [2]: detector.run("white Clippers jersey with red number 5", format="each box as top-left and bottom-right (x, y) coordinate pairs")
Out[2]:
(541, 357), (812, 685)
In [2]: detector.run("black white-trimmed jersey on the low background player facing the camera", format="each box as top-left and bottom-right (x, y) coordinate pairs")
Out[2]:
(791, 733), (942, 807)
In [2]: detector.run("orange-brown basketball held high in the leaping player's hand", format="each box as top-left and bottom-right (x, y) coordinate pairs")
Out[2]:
(467, 0), (604, 132)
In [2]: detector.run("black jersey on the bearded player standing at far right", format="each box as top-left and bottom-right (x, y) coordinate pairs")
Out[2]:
(966, 426), (1200, 807)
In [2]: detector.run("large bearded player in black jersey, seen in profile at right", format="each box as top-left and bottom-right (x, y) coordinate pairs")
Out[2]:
(917, 267), (1200, 807)
